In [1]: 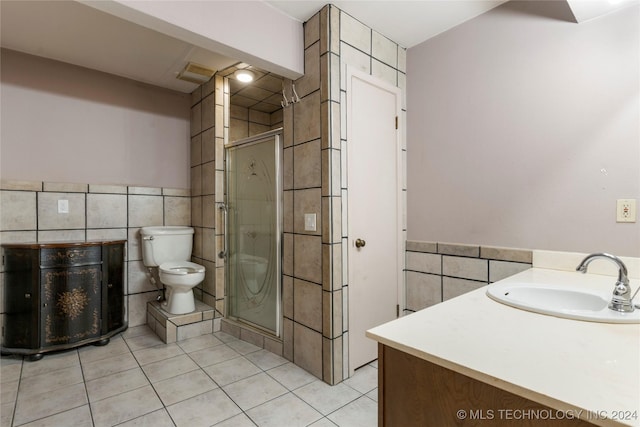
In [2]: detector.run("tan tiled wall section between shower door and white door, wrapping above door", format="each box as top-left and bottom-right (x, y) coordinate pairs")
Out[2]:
(283, 5), (406, 384)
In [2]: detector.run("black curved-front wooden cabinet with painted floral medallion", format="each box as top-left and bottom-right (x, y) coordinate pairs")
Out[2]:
(2, 240), (127, 360)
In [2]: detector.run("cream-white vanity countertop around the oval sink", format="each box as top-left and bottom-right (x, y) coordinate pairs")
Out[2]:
(367, 268), (640, 426)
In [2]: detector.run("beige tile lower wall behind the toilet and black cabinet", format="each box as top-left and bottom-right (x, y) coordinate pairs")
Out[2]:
(0, 180), (191, 332)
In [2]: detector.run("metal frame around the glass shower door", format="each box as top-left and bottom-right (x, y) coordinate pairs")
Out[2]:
(223, 128), (284, 339)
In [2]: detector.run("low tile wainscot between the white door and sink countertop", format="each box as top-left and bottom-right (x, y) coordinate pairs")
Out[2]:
(405, 241), (533, 313)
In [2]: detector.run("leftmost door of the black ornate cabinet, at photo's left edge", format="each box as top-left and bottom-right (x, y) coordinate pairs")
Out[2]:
(2, 248), (40, 349)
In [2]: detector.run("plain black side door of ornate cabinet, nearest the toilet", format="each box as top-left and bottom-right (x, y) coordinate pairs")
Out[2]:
(102, 243), (125, 334)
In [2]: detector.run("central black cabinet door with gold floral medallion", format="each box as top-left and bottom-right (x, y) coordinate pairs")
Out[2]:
(40, 264), (102, 347)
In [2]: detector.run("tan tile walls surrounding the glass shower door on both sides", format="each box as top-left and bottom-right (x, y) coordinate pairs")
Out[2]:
(191, 5), (406, 384)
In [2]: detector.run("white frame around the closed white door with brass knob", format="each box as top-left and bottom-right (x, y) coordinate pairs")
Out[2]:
(343, 65), (405, 376)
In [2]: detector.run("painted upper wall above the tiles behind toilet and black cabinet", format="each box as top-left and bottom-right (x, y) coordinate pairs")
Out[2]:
(0, 49), (191, 188)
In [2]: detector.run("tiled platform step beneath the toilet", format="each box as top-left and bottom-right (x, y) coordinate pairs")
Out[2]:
(147, 300), (215, 344)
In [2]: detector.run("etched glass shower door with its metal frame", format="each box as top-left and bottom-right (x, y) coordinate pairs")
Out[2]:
(221, 129), (282, 337)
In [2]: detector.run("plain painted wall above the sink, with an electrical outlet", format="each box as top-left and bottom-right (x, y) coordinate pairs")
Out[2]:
(407, 1), (640, 256)
